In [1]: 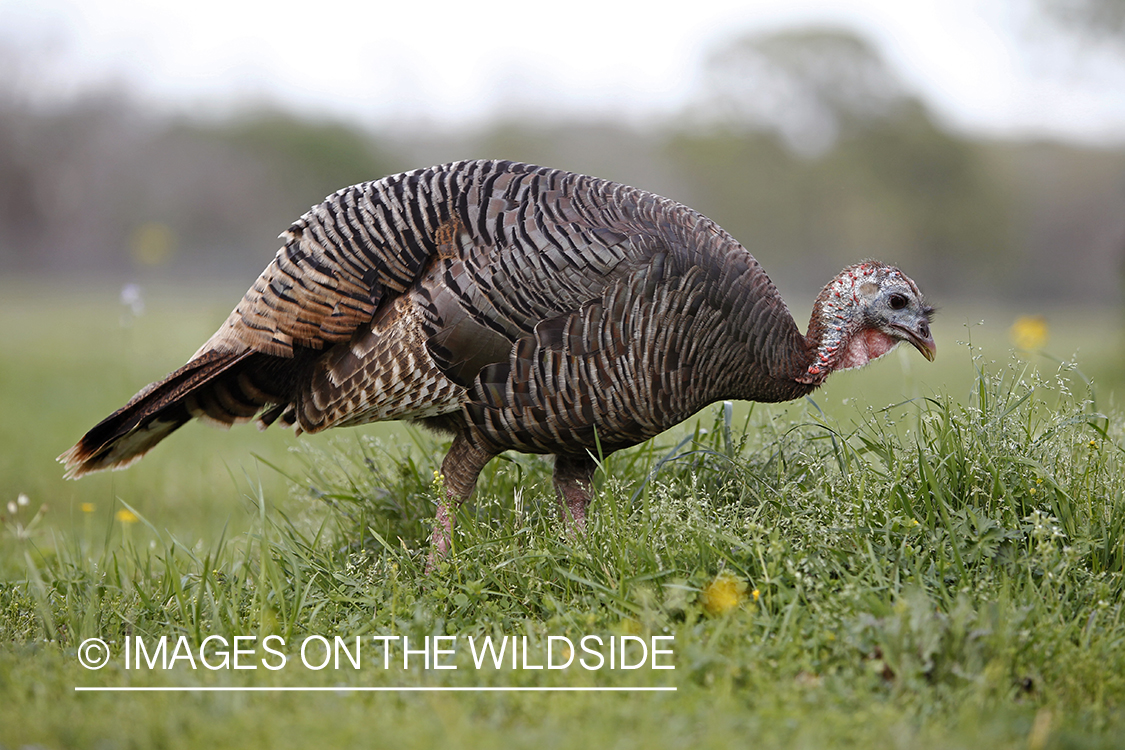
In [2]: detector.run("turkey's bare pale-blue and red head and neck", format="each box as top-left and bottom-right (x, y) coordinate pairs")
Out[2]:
(800, 261), (937, 383)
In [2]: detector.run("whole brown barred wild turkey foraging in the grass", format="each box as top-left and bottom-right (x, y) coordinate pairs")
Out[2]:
(60, 161), (936, 554)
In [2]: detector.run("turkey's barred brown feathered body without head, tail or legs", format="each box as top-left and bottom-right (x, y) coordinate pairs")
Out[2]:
(239, 155), (808, 445)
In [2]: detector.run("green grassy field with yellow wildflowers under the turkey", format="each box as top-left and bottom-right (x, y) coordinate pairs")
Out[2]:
(0, 284), (1125, 748)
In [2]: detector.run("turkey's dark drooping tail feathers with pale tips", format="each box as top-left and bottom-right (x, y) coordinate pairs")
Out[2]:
(59, 350), (258, 479)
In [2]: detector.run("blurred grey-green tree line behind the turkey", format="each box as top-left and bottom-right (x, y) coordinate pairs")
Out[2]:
(0, 30), (1125, 302)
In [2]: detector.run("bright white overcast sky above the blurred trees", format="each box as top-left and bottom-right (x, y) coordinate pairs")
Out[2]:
(0, 0), (1125, 143)
